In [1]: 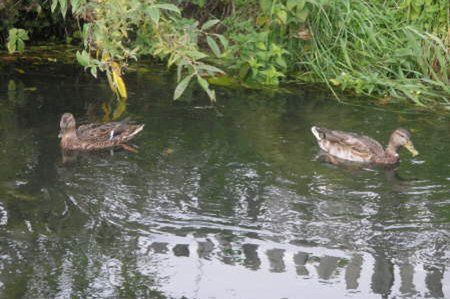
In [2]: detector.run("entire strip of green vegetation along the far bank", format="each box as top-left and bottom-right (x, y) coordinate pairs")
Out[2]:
(0, 0), (450, 109)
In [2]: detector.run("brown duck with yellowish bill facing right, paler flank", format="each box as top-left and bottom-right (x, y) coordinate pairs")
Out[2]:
(311, 126), (419, 165)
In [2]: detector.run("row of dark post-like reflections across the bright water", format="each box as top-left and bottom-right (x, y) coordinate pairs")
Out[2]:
(122, 236), (444, 298)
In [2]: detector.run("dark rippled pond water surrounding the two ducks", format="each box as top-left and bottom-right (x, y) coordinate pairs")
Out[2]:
(0, 59), (450, 299)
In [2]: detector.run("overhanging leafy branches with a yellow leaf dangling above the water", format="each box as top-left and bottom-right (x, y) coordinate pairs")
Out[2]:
(67, 0), (226, 101)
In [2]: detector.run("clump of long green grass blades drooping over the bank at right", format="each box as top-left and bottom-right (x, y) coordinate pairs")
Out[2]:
(296, 1), (450, 107)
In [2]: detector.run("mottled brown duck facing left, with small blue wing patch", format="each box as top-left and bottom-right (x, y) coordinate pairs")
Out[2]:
(58, 113), (144, 151)
